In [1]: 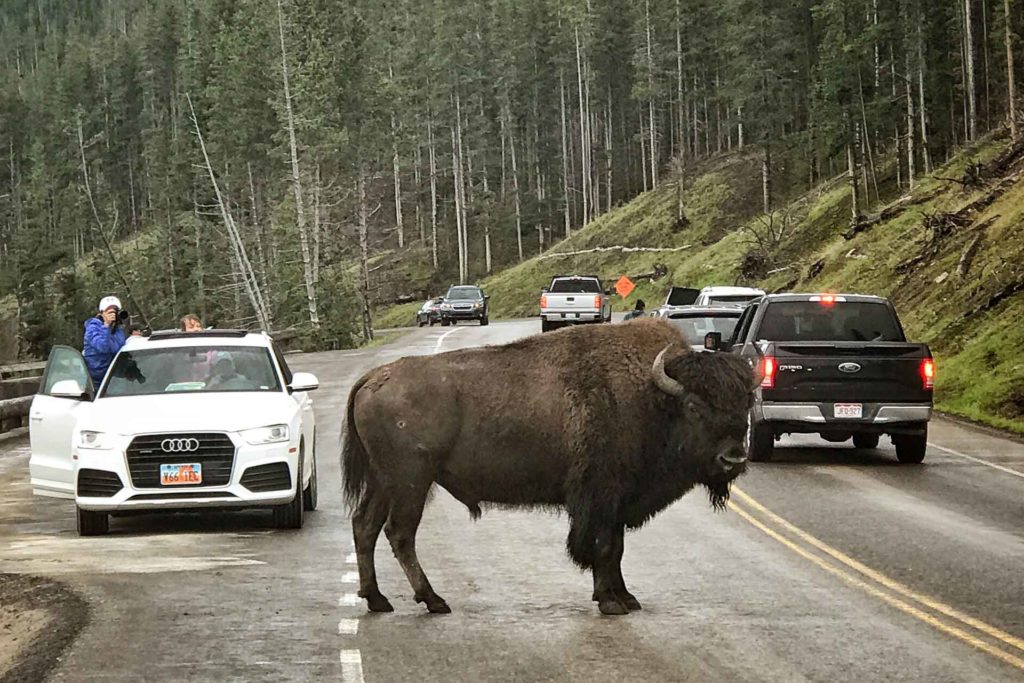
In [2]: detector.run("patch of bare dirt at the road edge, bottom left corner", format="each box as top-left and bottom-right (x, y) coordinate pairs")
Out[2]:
(0, 573), (89, 683)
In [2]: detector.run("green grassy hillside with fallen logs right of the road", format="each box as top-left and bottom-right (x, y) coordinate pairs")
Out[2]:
(377, 139), (1024, 433)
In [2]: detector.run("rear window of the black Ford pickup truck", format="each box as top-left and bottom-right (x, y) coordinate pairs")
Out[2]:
(757, 301), (904, 342)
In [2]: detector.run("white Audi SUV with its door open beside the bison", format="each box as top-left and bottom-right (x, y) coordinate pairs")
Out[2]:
(29, 330), (317, 536)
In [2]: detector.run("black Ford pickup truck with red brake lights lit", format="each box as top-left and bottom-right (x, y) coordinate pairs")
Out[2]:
(724, 294), (935, 463)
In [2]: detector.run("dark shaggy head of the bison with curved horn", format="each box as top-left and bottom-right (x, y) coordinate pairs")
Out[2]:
(651, 346), (759, 508)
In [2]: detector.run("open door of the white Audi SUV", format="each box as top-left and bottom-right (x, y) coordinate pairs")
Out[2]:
(29, 346), (94, 498)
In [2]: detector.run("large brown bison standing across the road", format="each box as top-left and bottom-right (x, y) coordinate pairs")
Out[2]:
(342, 318), (757, 614)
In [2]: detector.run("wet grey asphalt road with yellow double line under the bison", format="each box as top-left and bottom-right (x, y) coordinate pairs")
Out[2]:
(0, 321), (1024, 683)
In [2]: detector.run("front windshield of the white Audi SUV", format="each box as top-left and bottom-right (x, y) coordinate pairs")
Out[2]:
(100, 346), (281, 397)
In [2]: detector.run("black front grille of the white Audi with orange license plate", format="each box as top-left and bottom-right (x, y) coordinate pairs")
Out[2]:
(125, 433), (234, 489)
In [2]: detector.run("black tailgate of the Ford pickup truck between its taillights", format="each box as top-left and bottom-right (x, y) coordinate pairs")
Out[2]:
(762, 342), (932, 403)
